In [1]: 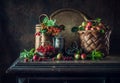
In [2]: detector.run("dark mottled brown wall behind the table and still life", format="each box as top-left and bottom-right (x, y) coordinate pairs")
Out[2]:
(0, 0), (120, 80)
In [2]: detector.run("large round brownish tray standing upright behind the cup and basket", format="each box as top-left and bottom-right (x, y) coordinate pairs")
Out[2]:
(50, 8), (87, 49)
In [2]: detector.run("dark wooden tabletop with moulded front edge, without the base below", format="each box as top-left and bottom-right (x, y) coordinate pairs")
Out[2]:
(6, 56), (120, 76)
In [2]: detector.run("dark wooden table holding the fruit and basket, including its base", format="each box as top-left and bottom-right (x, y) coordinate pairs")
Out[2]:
(6, 55), (120, 83)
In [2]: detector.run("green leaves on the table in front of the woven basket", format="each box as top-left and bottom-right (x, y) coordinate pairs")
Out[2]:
(88, 50), (104, 60)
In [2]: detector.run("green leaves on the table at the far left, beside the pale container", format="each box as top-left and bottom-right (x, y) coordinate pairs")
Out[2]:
(20, 48), (35, 59)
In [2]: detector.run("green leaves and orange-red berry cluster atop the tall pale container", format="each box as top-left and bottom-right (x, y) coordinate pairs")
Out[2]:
(40, 15), (65, 36)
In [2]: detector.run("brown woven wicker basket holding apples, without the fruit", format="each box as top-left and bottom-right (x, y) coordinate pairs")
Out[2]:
(78, 30), (111, 56)
